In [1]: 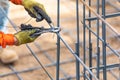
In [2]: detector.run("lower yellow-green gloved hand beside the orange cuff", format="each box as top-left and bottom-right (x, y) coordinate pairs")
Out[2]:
(14, 30), (38, 45)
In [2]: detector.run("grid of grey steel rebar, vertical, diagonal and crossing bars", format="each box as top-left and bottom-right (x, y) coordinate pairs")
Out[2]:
(0, 0), (120, 80)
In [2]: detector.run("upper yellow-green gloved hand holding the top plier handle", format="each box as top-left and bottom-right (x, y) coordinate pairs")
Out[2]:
(22, 0), (47, 21)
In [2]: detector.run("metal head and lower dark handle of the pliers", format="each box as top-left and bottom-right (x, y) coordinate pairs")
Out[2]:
(21, 24), (61, 37)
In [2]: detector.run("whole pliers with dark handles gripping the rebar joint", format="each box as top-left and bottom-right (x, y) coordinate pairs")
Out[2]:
(21, 6), (61, 37)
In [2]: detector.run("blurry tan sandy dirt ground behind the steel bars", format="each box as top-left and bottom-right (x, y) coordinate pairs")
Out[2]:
(0, 0), (120, 80)
